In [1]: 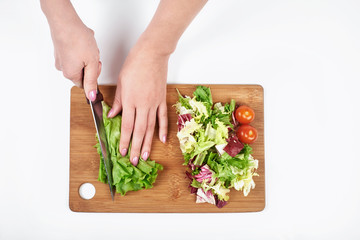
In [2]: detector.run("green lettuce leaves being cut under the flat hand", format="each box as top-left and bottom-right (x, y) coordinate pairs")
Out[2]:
(95, 102), (163, 196)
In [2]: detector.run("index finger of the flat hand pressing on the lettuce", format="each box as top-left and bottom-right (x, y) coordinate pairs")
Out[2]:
(119, 106), (135, 156)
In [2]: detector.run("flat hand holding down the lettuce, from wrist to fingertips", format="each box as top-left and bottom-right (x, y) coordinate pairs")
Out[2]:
(108, 40), (169, 166)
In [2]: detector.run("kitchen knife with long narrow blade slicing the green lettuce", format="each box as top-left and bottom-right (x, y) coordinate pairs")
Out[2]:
(87, 89), (114, 201)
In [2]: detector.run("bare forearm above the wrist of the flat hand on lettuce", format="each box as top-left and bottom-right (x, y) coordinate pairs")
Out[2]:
(139, 0), (207, 54)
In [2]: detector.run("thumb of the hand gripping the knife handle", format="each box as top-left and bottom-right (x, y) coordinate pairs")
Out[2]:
(84, 62), (101, 101)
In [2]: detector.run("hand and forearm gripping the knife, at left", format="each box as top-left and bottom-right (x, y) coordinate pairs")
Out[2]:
(42, 1), (101, 101)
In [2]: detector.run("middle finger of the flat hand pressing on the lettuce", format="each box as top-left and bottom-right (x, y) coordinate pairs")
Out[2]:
(130, 108), (149, 166)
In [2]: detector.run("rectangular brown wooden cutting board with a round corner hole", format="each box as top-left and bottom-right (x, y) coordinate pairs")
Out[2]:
(69, 85), (265, 213)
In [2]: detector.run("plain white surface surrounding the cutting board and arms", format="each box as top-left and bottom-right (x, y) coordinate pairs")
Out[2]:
(0, 0), (360, 239)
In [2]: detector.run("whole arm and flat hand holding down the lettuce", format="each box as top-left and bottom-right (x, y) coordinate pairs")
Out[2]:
(105, 0), (207, 165)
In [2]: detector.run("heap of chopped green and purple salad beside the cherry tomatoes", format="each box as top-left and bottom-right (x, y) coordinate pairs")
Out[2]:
(174, 86), (258, 208)
